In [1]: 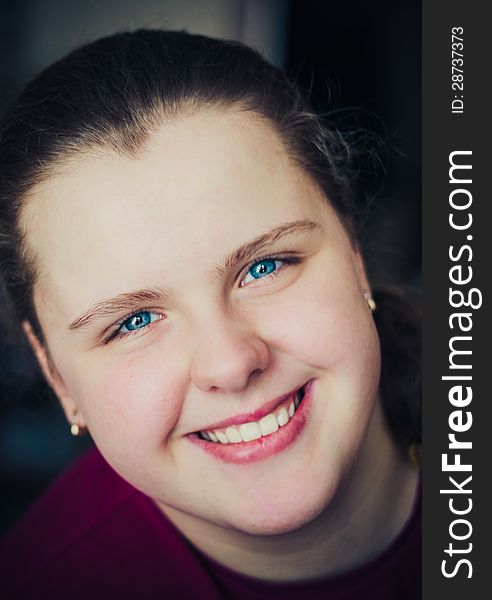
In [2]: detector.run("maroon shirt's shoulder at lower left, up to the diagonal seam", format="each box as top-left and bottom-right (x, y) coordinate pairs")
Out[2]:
(0, 449), (222, 600)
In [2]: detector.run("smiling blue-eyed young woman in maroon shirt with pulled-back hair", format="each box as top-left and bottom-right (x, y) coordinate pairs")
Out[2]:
(0, 31), (420, 600)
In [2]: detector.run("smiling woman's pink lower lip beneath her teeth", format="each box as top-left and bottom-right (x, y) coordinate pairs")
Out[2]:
(188, 380), (313, 465)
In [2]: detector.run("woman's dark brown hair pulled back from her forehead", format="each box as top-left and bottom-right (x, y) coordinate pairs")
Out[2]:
(0, 30), (419, 444)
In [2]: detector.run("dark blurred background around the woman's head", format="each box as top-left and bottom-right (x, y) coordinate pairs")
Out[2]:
(0, 0), (421, 534)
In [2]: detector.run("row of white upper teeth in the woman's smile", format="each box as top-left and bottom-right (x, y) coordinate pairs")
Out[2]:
(200, 389), (304, 444)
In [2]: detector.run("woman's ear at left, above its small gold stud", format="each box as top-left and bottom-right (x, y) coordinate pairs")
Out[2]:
(22, 321), (85, 428)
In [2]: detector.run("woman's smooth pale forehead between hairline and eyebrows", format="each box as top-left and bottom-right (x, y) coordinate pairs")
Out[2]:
(23, 111), (330, 318)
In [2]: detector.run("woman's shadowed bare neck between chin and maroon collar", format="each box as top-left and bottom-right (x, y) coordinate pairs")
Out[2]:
(160, 403), (419, 582)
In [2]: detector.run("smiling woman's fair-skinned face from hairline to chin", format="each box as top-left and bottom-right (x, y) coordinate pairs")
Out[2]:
(23, 111), (380, 533)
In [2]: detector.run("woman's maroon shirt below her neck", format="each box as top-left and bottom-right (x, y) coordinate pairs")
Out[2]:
(0, 450), (421, 600)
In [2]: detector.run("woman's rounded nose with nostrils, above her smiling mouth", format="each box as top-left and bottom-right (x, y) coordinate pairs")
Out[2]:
(191, 318), (270, 392)
